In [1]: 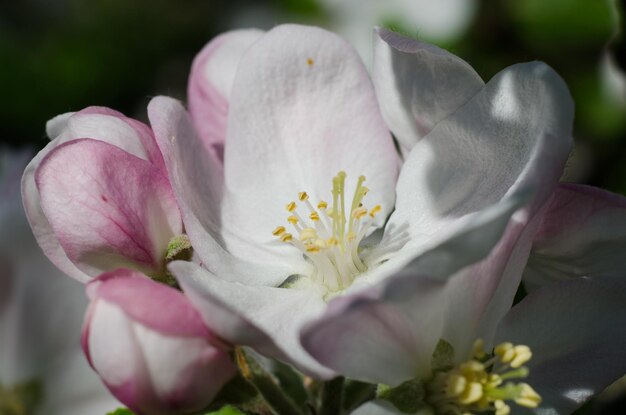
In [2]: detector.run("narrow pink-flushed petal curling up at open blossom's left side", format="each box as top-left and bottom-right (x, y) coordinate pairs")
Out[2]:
(148, 97), (294, 285)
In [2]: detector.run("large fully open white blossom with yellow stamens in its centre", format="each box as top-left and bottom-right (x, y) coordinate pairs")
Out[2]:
(149, 25), (623, 412)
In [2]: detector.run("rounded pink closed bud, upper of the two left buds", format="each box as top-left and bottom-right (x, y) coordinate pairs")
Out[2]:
(22, 107), (182, 282)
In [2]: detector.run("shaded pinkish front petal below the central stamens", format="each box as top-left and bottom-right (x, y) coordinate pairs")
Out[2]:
(302, 278), (447, 386)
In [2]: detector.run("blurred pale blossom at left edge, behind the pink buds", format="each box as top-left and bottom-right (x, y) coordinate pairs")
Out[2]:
(0, 150), (120, 415)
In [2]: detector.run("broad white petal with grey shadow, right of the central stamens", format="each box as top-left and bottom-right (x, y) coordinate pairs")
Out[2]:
(389, 63), (573, 250)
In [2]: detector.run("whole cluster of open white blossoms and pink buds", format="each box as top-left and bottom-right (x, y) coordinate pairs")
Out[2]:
(17, 25), (626, 415)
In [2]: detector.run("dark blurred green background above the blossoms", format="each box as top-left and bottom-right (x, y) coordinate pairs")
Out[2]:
(0, 0), (626, 414)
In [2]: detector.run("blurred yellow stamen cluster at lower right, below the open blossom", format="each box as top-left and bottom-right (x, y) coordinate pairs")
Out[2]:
(428, 340), (541, 415)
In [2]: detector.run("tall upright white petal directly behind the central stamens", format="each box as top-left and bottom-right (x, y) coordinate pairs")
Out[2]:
(222, 25), (398, 270)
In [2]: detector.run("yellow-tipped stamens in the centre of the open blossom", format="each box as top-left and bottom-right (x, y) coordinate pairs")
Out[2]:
(272, 171), (382, 292)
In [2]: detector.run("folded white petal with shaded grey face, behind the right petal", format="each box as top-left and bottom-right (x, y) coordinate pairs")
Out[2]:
(372, 29), (484, 154)
